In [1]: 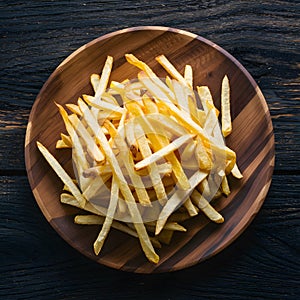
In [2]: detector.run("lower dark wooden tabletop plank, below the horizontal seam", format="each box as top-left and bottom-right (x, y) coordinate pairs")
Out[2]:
(0, 175), (300, 299)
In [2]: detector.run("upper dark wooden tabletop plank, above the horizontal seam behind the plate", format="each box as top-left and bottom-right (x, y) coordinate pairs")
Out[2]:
(0, 1), (300, 171)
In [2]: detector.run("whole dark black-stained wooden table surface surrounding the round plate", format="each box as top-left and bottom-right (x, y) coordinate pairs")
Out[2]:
(0, 0), (300, 299)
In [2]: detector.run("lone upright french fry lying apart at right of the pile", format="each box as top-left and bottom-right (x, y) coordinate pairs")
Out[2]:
(221, 75), (232, 137)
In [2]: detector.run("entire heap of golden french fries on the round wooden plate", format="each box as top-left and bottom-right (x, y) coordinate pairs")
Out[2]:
(37, 54), (242, 263)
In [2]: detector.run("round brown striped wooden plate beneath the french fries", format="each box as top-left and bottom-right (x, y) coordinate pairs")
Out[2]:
(25, 26), (274, 273)
